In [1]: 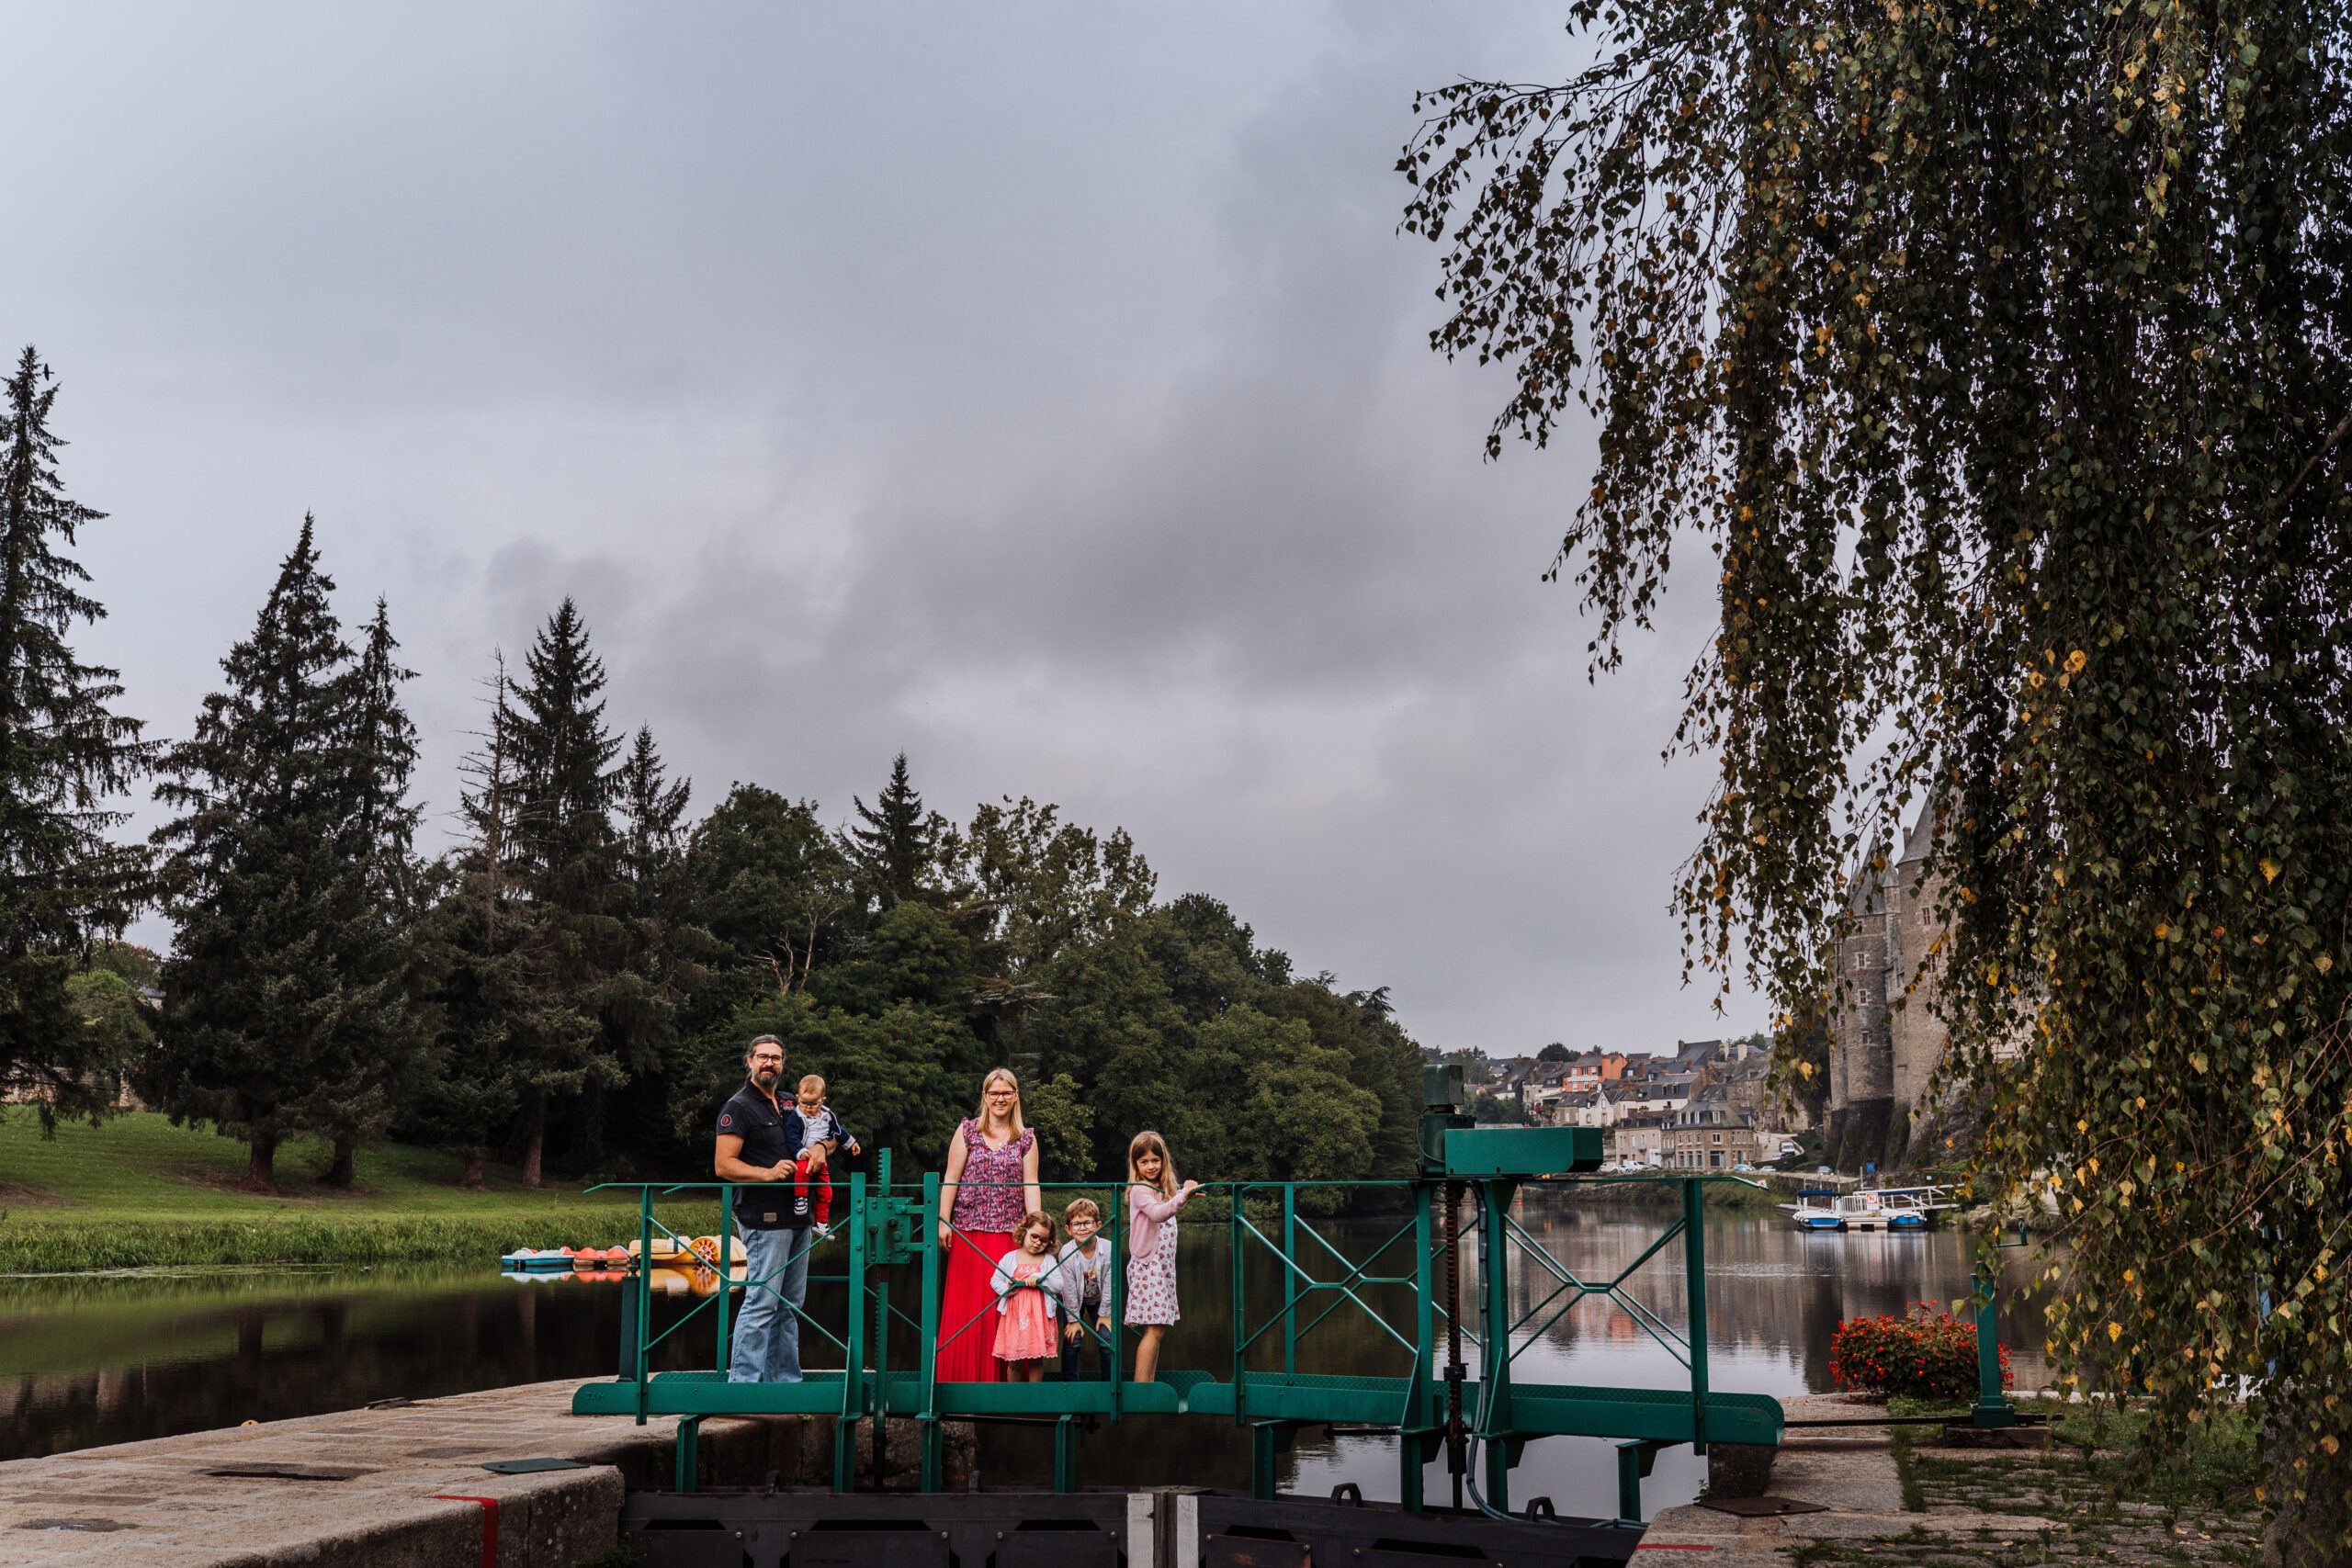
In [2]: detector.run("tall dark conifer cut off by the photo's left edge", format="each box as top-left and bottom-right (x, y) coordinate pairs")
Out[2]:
(0, 348), (153, 1131)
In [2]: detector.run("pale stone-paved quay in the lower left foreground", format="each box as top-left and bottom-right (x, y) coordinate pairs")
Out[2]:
(0, 1380), (797, 1568)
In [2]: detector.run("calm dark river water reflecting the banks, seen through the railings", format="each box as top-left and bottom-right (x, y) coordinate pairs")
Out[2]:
(0, 1197), (2041, 1514)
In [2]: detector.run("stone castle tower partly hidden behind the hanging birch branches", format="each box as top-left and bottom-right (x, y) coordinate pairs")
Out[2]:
(1827, 808), (1945, 1170)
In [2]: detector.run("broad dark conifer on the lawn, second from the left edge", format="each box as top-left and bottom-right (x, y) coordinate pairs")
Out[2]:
(148, 517), (416, 1192)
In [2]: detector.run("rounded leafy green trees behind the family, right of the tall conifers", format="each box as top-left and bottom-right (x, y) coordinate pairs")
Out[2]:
(673, 775), (1420, 1180)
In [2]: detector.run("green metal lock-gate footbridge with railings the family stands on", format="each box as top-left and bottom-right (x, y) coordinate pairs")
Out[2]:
(571, 1067), (1782, 1521)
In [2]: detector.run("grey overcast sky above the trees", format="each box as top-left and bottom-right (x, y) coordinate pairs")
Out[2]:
(0, 0), (1761, 1054)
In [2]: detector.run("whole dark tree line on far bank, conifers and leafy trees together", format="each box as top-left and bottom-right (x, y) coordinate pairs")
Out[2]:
(0, 350), (1420, 1192)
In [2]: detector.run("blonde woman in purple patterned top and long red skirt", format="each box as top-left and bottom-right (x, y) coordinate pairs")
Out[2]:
(933, 1067), (1045, 1382)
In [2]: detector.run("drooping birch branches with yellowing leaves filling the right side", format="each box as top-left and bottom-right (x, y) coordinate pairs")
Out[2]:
(1402, 0), (2352, 1559)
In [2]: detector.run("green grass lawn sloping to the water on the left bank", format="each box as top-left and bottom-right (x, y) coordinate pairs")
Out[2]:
(0, 1107), (718, 1272)
